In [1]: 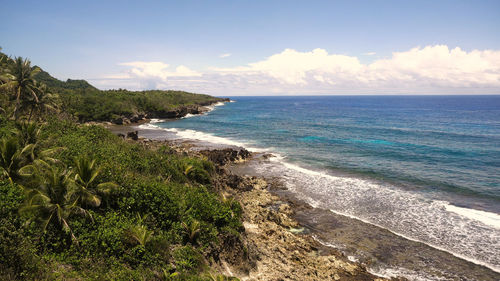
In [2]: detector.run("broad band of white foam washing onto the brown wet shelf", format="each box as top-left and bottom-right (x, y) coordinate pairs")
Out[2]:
(256, 154), (500, 272)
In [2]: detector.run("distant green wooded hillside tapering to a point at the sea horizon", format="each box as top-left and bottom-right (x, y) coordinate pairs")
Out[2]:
(0, 53), (227, 122)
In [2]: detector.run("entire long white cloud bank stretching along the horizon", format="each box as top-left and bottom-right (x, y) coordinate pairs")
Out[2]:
(92, 45), (500, 95)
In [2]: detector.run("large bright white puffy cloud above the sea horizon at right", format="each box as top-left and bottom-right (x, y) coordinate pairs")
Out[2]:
(214, 45), (500, 92)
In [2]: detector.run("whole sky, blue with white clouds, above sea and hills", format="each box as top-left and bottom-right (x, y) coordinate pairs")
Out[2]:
(0, 0), (500, 96)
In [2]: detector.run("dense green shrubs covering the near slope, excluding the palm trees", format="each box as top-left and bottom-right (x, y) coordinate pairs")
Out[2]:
(0, 114), (243, 280)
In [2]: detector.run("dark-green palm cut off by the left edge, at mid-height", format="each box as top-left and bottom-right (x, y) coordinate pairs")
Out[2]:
(0, 138), (33, 183)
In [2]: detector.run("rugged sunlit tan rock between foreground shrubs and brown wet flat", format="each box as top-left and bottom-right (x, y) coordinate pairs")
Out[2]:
(229, 177), (383, 281)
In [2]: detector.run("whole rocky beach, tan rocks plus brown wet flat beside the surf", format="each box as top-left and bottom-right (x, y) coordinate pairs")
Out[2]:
(106, 99), (498, 280)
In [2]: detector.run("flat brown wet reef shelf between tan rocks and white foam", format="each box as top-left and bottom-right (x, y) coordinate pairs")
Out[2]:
(231, 154), (499, 280)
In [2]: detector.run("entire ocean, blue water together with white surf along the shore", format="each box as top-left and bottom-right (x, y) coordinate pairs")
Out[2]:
(143, 96), (500, 279)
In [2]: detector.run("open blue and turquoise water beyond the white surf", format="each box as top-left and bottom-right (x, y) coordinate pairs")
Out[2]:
(166, 96), (500, 203)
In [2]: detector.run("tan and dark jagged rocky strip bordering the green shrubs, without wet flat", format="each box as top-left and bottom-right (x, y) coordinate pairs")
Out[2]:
(104, 126), (394, 280)
